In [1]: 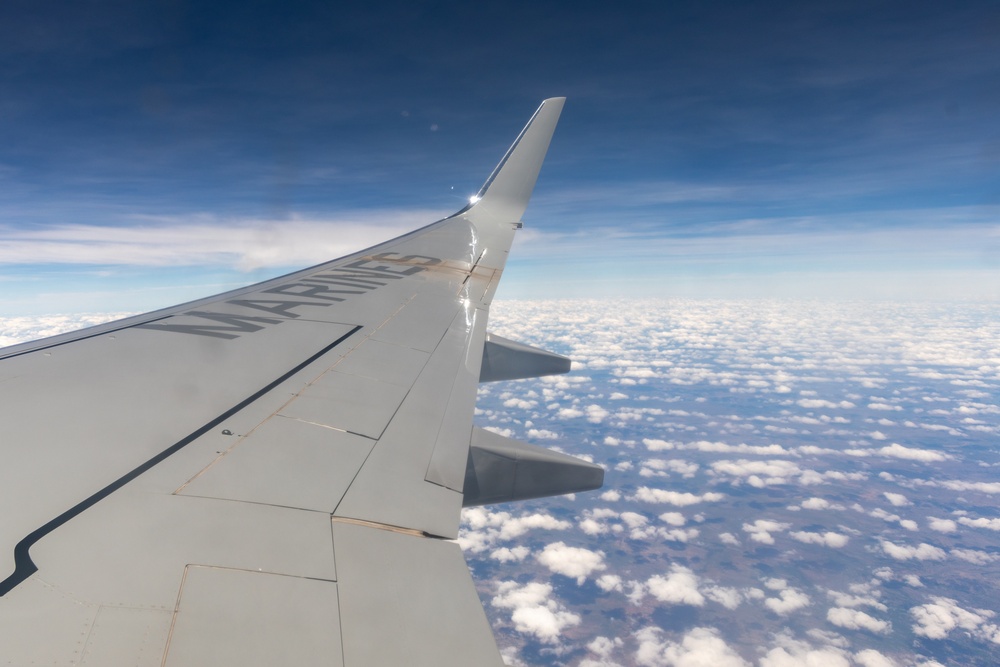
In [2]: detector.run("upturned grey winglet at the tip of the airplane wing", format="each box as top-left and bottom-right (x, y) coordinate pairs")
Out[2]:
(464, 97), (566, 222)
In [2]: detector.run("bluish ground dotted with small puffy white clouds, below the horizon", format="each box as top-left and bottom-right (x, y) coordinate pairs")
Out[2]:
(460, 300), (1000, 667)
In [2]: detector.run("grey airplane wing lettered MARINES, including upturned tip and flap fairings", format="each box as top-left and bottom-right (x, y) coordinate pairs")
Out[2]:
(0, 98), (603, 667)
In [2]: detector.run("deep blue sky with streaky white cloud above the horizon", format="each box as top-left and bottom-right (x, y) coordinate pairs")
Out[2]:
(0, 1), (1000, 315)
